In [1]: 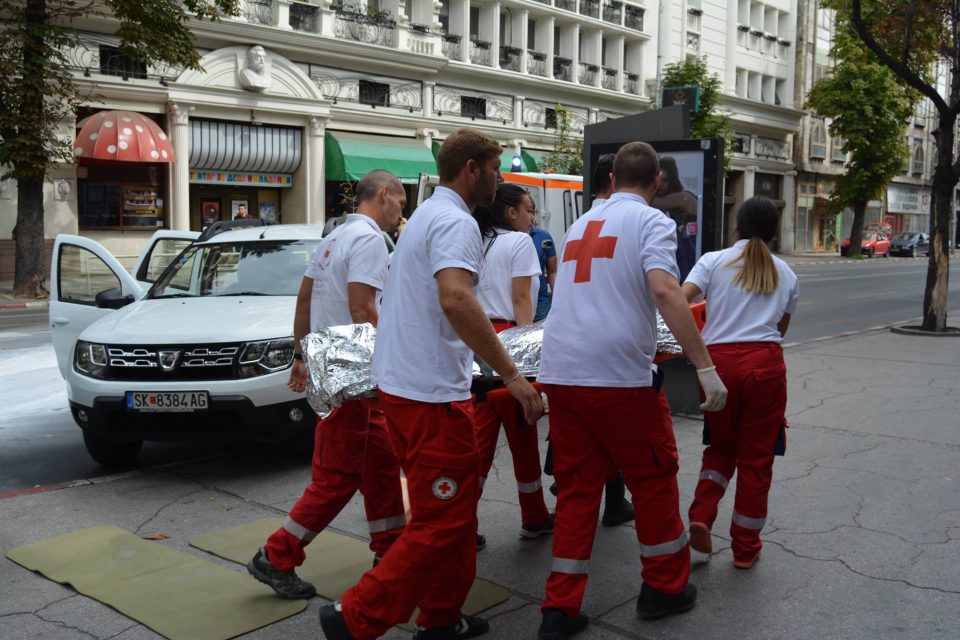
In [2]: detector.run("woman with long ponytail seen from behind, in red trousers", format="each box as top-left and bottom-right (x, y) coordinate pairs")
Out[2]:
(683, 196), (799, 569)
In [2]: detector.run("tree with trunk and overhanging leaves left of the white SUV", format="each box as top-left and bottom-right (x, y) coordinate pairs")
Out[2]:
(0, 0), (239, 297)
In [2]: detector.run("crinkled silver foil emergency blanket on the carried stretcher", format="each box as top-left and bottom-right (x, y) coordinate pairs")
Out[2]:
(301, 313), (682, 418)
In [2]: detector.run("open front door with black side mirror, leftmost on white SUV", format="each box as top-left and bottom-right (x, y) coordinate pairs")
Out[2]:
(50, 234), (146, 377)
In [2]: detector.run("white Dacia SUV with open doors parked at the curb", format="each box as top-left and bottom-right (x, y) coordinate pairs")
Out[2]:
(50, 221), (322, 466)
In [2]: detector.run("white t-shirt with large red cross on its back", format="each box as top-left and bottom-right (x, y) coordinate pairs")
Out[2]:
(538, 193), (678, 387)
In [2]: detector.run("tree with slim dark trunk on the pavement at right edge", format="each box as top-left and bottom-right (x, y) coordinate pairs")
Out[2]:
(844, 0), (960, 332)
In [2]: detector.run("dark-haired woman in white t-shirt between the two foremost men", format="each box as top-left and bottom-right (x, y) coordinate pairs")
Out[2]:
(473, 183), (553, 546)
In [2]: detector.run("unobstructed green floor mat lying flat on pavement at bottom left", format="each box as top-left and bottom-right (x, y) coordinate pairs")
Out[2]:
(7, 526), (306, 640)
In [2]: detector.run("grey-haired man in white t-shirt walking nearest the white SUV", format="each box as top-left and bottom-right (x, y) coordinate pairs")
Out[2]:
(247, 170), (407, 599)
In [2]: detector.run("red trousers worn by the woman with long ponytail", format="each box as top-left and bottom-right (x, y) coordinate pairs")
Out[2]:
(689, 342), (787, 562)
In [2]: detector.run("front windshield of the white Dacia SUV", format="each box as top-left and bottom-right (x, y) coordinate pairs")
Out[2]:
(147, 239), (319, 299)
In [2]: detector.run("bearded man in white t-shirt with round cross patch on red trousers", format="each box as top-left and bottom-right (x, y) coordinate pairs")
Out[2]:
(320, 129), (543, 640)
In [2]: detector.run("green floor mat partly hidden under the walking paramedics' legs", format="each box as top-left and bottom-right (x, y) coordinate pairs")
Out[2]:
(190, 518), (510, 629)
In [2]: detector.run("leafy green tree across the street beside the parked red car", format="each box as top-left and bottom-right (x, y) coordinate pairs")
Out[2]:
(806, 16), (917, 256)
